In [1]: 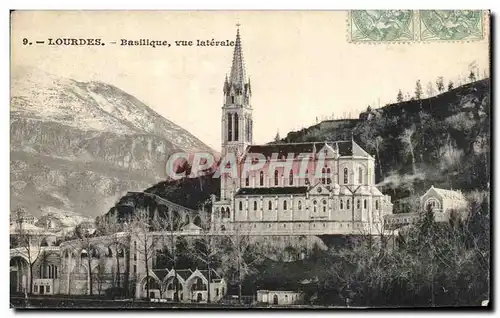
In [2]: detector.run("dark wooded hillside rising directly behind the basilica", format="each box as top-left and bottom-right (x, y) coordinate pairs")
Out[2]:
(111, 79), (491, 220)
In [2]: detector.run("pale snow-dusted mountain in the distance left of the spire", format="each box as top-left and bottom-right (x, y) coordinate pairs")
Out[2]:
(10, 68), (213, 217)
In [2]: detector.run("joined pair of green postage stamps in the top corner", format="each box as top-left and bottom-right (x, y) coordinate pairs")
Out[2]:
(348, 10), (485, 43)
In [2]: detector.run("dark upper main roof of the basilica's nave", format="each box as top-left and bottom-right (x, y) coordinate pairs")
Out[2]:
(243, 141), (360, 158)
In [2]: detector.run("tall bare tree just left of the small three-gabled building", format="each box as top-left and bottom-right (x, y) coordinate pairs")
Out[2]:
(130, 207), (159, 298)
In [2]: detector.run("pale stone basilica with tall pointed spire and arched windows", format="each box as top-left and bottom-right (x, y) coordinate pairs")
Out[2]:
(211, 29), (392, 235)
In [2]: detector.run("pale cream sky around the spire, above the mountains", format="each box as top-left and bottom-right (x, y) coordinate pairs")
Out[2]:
(11, 11), (489, 151)
